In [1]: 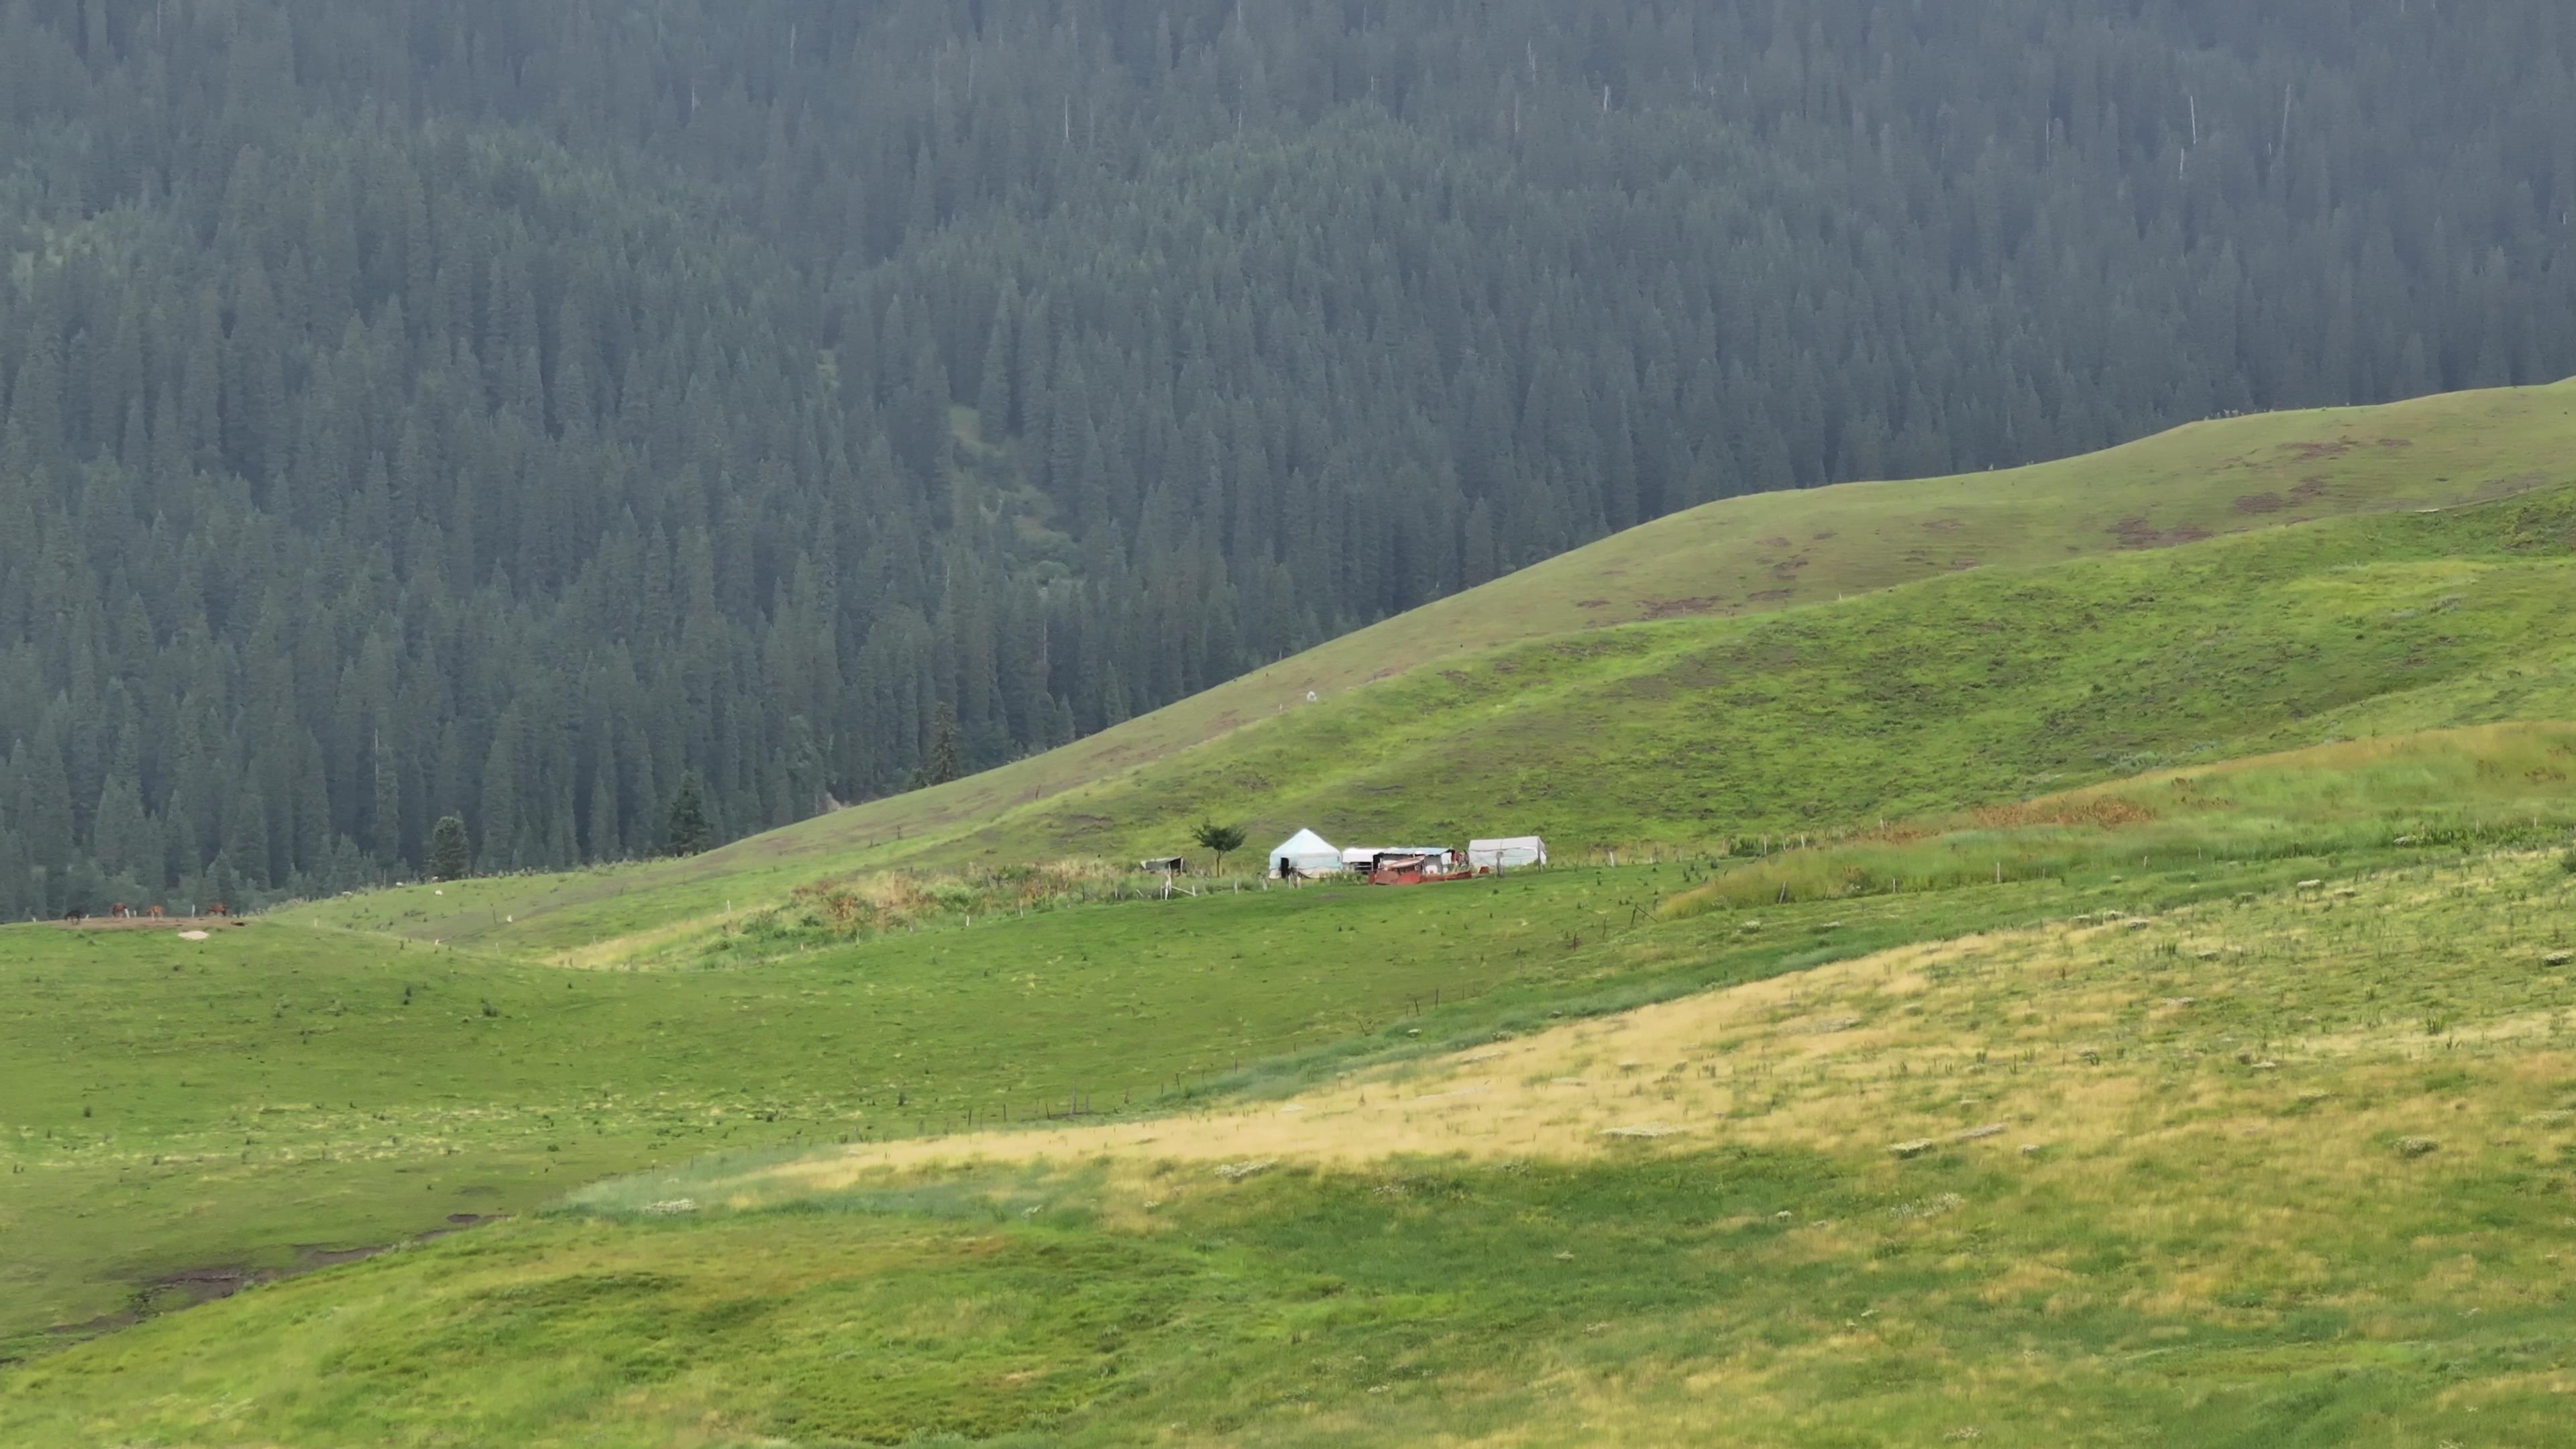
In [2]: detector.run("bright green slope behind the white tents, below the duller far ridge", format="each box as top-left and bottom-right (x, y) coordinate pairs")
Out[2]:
(292, 469), (2576, 951)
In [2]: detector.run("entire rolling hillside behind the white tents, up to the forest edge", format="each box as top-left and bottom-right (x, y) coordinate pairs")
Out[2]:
(282, 384), (2576, 951)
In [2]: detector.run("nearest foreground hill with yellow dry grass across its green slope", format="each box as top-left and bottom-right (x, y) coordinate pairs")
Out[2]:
(0, 853), (2576, 1446)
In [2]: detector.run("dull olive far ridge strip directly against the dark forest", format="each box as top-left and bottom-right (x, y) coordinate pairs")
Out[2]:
(276, 382), (2576, 951)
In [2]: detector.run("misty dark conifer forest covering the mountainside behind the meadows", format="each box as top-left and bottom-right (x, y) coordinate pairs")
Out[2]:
(0, 0), (2576, 913)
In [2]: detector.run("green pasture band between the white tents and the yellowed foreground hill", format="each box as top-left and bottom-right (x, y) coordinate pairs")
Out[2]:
(15, 727), (2571, 1354)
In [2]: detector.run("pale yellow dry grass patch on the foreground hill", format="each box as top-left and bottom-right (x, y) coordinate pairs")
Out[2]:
(742, 887), (2558, 1201)
